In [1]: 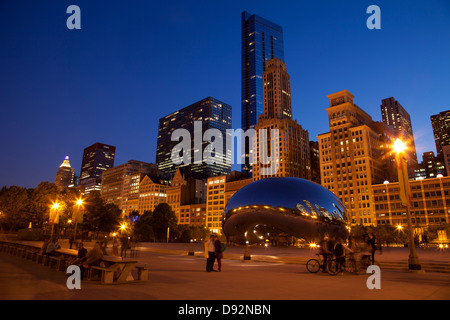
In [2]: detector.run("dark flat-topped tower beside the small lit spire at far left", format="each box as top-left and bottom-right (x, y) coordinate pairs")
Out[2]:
(80, 143), (116, 193)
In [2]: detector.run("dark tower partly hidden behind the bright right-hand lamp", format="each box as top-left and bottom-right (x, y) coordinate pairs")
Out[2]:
(381, 97), (417, 174)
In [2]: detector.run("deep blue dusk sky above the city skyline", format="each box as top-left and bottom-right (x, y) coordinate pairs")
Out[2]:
(0, 0), (450, 187)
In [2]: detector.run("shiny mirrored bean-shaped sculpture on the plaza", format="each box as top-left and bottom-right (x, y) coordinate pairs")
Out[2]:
(222, 178), (348, 244)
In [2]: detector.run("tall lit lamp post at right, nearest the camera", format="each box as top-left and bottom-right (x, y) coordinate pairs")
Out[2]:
(393, 139), (422, 270)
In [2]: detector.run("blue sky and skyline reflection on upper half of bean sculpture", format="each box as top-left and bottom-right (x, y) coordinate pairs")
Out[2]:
(225, 178), (347, 222)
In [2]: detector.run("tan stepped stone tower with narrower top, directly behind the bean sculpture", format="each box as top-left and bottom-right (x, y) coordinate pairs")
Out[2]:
(253, 58), (311, 180)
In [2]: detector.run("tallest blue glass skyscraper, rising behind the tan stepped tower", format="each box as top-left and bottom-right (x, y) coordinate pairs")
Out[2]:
(241, 11), (284, 172)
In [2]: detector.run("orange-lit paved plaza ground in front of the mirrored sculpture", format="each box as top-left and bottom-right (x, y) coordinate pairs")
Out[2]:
(0, 244), (450, 301)
